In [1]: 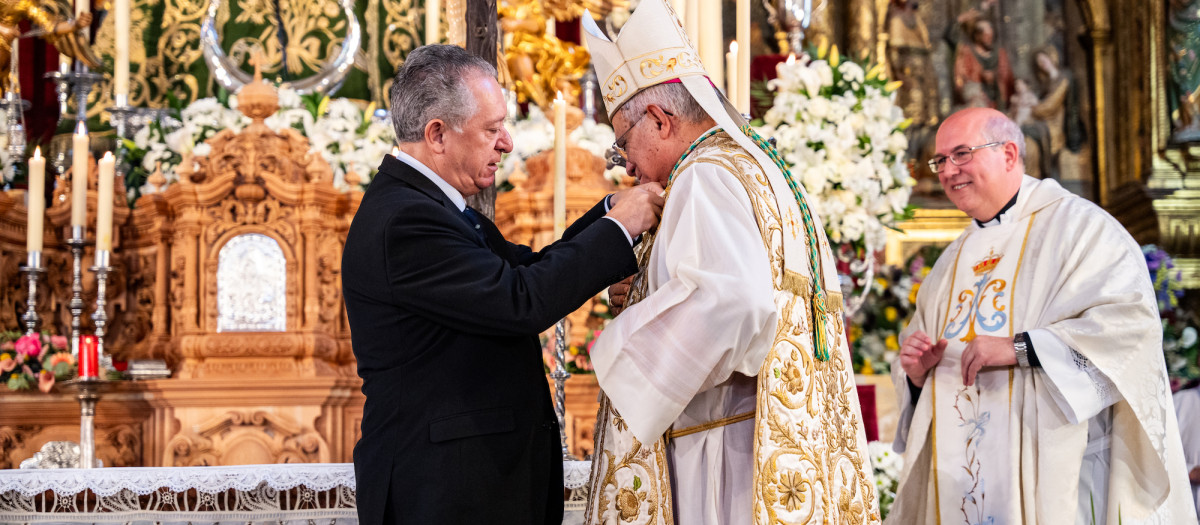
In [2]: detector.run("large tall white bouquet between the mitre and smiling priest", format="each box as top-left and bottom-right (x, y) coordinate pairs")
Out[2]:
(758, 47), (914, 258)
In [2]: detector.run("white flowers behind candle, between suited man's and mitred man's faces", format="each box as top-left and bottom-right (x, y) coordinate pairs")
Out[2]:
(496, 104), (625, 187)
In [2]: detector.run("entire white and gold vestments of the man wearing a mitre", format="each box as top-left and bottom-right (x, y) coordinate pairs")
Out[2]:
(587, 132), (880, 525)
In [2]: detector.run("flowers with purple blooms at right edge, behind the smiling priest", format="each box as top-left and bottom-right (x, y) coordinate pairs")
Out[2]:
(1141, 245), (1200, 391)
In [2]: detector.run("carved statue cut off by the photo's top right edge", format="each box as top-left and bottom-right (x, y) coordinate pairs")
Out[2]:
(1166, 0), (1200, 143)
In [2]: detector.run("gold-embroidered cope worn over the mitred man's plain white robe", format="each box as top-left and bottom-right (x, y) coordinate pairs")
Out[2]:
(584, 132), (880, 525)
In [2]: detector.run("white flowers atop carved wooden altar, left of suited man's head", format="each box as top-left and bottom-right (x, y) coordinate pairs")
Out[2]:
(125, 86), (395, 200)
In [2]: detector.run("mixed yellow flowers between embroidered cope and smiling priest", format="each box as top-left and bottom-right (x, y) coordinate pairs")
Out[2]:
(850, 246), (942, 374)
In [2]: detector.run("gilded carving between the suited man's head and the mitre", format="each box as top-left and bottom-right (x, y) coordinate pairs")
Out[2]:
(497, 0), (592, 113)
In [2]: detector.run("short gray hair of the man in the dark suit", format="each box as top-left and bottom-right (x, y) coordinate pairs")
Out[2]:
(388, 44), (496, 144)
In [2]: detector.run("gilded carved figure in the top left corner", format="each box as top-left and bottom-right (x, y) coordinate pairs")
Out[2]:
(0, 0), (101, 92)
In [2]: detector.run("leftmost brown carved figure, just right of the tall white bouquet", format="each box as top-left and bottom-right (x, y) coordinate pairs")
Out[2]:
(887, 0), (940, 126)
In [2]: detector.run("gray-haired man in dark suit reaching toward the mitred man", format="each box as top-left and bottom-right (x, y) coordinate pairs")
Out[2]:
(342, 46), (662, 525)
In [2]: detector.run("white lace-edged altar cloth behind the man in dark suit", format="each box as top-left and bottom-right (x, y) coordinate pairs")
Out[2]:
(0, 461), (590, 525)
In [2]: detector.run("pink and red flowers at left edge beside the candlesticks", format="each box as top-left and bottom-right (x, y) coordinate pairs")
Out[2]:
(0, 332), (76, 392)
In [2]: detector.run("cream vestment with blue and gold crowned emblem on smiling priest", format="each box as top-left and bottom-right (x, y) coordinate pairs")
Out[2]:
(888, 176), (1195, 525)
